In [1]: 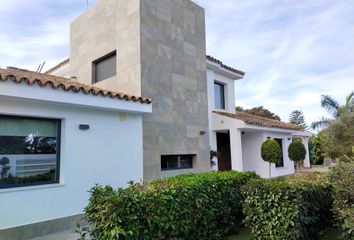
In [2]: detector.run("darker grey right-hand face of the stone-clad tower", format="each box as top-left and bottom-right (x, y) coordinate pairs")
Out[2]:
(140, 0), (210, 180)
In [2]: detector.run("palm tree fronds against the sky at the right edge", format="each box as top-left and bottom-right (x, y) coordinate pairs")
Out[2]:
(311, 91), (354, 129)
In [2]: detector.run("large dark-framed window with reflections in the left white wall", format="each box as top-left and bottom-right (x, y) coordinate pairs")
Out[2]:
(0, 115), (60, 188)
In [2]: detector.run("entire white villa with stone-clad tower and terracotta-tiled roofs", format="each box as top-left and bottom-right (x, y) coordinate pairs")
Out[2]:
(0, 0), (311, 240)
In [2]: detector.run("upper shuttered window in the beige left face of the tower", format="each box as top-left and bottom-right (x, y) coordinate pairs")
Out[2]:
(92, 51), (117, 83)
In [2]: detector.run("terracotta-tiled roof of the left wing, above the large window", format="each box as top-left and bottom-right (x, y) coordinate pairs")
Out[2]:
(0, 67), (151, 104)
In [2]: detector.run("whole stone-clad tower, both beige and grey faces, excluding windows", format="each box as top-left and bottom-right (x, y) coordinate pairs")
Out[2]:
(67, 0), (210, 180)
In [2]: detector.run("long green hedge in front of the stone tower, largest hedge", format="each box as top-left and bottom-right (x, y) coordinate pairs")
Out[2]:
(80, 171), (258, 240)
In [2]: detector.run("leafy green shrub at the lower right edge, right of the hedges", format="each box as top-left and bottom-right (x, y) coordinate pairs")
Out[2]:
(329, 162), (354, 240)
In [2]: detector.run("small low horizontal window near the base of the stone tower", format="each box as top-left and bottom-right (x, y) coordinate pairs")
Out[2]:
(161, 155), (196, 170)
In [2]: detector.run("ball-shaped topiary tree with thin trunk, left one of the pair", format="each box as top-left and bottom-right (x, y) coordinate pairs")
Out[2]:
(261, 139), (281, 178)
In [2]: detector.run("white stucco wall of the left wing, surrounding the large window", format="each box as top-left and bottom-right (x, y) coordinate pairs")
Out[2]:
(0, 96), (143, 229)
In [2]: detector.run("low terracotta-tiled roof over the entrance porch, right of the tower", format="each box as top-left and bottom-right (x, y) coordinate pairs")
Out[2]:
(213, 111), (300, 130)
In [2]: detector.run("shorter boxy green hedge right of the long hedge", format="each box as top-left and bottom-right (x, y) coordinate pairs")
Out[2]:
(242, 174), (331, 240)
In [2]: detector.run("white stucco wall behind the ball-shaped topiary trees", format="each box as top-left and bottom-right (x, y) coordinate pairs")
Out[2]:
(241, 129), (295, 178)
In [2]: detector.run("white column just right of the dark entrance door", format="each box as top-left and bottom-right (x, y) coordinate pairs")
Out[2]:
(230, 128), (243, 171)
